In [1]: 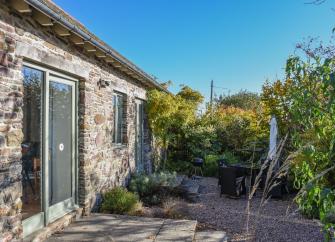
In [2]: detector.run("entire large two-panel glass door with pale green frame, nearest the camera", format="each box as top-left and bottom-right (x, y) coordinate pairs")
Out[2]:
(21, 63), (77, 237)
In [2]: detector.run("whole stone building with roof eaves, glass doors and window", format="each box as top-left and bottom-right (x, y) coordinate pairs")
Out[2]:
(0, 0), (163, 241)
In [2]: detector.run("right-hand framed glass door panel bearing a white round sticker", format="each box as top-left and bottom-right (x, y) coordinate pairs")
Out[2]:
(47, 77), (75, 222)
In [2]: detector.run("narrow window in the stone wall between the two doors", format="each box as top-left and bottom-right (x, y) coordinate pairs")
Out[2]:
(113, 93), (126, 144)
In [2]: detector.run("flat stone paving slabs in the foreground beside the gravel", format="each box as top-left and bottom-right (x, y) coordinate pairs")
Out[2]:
(47, 214), (198, 242)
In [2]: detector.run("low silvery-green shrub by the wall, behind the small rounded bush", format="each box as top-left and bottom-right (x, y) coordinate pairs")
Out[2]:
(129, 172), (176, 205)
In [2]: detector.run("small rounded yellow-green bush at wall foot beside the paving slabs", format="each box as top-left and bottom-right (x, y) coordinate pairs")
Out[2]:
(102, 187), (139, 214)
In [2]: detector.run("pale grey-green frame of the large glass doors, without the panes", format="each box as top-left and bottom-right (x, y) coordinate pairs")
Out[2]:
(22, 61), (79, 237)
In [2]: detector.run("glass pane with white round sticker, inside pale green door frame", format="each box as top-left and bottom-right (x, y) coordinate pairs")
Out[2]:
(49, 81), (73, 205)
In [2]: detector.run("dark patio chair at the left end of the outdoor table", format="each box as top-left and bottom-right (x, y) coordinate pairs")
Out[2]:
(219, 167), (246, 197)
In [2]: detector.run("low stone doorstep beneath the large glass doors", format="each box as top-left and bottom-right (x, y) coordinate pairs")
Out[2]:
(23, 208), (83, 242)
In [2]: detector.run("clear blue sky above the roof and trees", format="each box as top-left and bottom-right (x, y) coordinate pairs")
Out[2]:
(54, 0), (335, 98)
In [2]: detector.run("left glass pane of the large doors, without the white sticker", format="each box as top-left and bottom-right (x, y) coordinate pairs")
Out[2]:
(21, 67), (44, 219)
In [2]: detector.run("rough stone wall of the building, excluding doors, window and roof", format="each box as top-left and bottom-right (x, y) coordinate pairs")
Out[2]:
(0, 0), (151, 241)
